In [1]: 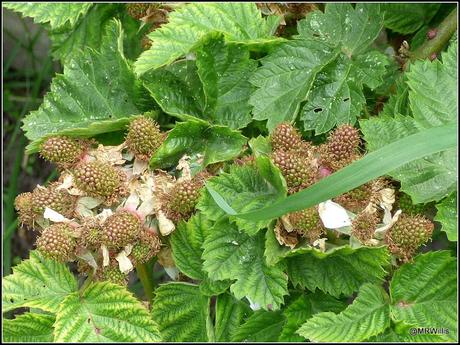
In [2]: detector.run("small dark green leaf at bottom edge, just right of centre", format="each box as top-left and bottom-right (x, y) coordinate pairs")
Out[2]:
(232, 310), (286, 343)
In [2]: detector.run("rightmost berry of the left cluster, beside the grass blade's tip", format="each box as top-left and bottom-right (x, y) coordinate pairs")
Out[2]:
(165, 178), (204, 222)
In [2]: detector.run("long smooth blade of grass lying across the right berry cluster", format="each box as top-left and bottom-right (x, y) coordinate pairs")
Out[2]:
(206, 124), (457, 221)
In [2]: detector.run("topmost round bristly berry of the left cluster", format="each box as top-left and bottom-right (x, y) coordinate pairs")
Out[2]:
(126, 116), (164, 161)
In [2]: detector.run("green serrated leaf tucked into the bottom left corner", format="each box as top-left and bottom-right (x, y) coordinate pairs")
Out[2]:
(2, 313), (55, 343)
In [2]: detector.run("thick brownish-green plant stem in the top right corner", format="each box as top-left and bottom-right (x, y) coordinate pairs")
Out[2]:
(410, 8), (457, 61)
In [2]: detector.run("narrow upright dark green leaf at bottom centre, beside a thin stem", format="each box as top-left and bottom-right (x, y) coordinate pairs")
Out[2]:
(215, 293), (252, 342)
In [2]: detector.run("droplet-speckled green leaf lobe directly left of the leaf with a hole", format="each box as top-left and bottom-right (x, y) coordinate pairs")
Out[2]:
(249, 39), (338, 129)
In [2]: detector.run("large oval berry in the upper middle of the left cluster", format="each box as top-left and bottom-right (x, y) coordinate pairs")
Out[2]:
(74, 161), (124, 198)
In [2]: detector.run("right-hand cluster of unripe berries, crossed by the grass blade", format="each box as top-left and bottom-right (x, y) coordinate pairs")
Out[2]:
(270, 123), (434, 262)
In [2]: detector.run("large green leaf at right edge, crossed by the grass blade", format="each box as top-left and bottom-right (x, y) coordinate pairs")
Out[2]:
(360, 44), (457, 203)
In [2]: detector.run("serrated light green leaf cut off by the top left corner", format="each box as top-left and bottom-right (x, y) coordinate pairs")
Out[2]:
(2, 2), (93, 29)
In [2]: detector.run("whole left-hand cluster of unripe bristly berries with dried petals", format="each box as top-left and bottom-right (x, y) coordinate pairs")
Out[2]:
(15, 116), (202, 284)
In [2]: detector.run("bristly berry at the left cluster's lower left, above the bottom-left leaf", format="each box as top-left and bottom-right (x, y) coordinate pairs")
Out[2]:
(37, 223), (76, 262)
